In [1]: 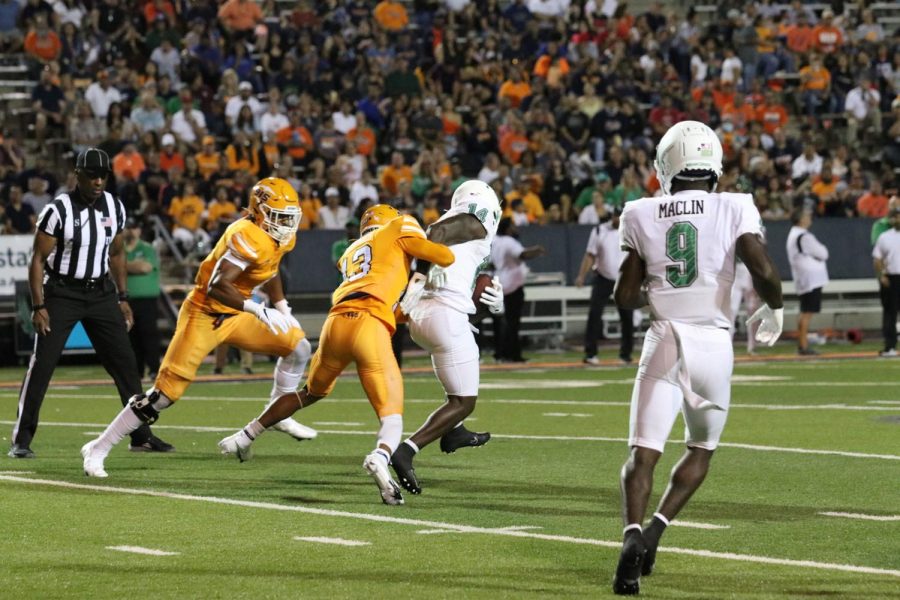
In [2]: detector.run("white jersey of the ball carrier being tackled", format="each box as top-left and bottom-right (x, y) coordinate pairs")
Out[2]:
(422, 202), (500, 315)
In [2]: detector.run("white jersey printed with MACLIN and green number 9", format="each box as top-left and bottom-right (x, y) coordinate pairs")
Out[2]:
(619, 190), (762, 328)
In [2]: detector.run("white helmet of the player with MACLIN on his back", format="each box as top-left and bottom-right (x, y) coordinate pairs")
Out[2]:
(653, 121), (722, 195)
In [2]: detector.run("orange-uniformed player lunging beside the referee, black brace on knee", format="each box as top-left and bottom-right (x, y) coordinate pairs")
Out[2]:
(81, 177), (316, 477)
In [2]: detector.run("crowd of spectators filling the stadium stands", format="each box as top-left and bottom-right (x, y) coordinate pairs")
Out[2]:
(0, 0), (900, 244)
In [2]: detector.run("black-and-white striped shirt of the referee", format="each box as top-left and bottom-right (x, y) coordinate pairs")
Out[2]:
(38, 192), (125, 279)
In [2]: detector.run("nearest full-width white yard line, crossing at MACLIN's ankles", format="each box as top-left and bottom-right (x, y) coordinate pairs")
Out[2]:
(0, 475), (900, 578)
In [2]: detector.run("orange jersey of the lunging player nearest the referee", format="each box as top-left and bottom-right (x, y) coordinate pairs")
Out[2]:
(187, 218), (297, 314)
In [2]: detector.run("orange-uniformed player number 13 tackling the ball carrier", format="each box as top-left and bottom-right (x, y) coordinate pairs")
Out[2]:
(219, 204), (454, 505)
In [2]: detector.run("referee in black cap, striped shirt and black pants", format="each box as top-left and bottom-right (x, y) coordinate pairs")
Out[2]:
(9, 148), (174, 458)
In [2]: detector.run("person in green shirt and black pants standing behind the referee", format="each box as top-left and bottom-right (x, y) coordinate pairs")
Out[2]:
(125, 218), (160, 380)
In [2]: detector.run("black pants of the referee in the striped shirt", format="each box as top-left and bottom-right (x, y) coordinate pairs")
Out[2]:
(12, 279), (150, 448)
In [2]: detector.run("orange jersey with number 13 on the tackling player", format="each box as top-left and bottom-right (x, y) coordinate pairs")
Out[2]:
(331, 215), (454, 333)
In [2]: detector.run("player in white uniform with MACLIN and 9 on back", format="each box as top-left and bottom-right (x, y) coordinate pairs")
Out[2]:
(613, 121), (784, 595)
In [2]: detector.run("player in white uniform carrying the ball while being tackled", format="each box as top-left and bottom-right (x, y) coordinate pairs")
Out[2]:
(391, 179), (503, 494)
